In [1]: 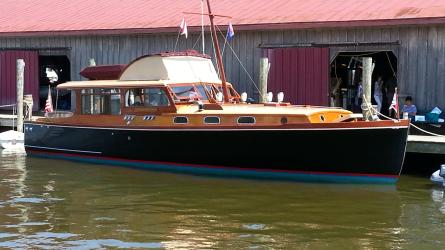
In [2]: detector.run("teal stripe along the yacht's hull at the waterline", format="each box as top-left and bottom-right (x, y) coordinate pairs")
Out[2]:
(28, 152), (398, 184)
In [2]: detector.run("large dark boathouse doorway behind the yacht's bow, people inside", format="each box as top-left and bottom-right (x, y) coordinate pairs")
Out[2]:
(329, 51), (397, 115)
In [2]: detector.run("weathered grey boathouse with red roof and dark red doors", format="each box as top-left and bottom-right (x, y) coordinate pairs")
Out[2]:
(0, 0), (445, 112)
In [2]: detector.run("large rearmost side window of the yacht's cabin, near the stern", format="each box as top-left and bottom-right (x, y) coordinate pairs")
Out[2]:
(81, 89), (121, 115)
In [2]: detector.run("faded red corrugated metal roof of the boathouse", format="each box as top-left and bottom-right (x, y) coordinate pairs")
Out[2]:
(0, 0), (445, 35)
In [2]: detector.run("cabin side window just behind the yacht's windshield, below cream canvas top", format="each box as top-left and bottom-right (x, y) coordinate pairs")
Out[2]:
(125, 88), (170, 107)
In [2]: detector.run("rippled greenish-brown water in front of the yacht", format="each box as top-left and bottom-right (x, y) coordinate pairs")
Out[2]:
(0, 151), (445, 249)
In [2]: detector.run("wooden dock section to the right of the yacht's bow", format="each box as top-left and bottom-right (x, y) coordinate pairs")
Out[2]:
(406, 135), (445, 155)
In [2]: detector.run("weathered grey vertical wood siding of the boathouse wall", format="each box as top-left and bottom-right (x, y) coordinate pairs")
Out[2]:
(0, 25), (445, 110)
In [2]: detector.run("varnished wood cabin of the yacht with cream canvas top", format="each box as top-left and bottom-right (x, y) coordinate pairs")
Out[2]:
(44, 52), (356, 127)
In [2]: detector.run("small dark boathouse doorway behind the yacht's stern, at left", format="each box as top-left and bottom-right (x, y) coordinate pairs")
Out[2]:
(39, 55), (71, 110)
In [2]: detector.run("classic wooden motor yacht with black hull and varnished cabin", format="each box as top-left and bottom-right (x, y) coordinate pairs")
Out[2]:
(25, 0), (409, 183)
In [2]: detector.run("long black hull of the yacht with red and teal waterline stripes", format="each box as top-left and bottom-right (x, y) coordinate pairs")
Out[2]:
(25, 123), (407, 183)
